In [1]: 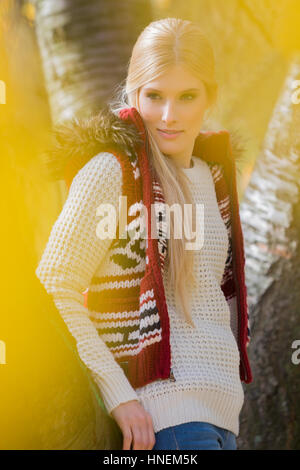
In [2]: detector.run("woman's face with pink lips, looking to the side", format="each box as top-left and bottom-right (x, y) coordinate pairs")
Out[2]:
(139, 65), (208, 168)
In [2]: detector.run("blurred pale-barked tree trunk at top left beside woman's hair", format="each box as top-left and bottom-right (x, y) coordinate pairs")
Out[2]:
(35, 0), (151, 122)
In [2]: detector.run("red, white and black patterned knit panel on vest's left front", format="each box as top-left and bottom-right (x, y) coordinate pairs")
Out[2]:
(84, 161), (168, 364)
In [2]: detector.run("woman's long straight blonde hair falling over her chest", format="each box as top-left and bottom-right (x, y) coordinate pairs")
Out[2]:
(110, 18), (218, 327)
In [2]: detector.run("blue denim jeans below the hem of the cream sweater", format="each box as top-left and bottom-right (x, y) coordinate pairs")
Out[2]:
(152, 421), (237, 450)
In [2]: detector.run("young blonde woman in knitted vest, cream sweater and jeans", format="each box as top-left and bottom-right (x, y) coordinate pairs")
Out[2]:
(36, 18), (252, 450)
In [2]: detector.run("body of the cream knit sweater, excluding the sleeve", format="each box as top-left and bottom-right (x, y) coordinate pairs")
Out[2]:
(136, 157), (244, 436)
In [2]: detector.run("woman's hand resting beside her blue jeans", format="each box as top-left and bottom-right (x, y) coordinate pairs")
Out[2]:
(111, 400), (155, 450)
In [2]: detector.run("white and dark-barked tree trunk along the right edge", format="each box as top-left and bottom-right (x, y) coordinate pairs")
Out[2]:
(239, 55), (300, 450)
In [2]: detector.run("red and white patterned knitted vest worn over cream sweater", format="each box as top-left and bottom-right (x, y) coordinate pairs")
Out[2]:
(64, 107), (252, 388)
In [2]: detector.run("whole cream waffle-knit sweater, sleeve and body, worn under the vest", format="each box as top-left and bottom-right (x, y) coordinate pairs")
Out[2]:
(36, 152), (244, 436)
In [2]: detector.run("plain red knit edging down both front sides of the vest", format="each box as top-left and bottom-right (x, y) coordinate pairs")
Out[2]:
(119, 107), (252, 383)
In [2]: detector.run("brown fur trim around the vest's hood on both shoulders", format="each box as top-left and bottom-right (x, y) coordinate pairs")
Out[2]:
(42, 106), (246, 183)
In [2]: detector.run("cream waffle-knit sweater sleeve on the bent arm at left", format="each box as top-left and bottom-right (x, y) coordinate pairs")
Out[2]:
(35, 152), (139, 413)
